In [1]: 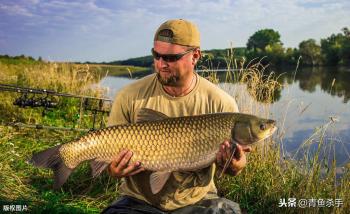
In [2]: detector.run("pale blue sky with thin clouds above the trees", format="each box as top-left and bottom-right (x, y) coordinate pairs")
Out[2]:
(0, 0), (350, 62)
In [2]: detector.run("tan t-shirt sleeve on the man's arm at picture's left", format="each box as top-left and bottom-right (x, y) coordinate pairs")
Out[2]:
(107, 91), (131, 126)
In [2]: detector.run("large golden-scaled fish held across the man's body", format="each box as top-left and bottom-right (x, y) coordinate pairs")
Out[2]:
(30, 109), (276, 194)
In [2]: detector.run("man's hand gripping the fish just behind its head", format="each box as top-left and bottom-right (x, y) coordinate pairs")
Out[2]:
(216, 141), (252, 175)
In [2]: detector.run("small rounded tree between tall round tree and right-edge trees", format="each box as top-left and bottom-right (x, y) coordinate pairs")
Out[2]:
(299, 39), (321, 65)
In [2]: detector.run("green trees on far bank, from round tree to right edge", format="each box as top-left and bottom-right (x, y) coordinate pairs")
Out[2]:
(246, 27), (350, 66)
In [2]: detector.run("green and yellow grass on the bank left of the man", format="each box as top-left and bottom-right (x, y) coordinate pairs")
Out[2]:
(0, 60), (118, 213)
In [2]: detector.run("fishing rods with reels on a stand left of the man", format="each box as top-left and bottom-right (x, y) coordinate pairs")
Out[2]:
(0, 84), (112, 131)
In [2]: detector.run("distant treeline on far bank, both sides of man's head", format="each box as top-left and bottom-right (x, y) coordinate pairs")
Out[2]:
(108, 27), (350, 68)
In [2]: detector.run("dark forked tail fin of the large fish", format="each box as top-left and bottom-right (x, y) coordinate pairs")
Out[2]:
(29, 145), (73, 189)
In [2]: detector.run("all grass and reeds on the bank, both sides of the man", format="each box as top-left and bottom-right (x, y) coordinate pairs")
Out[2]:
(0, 56), (350, 213)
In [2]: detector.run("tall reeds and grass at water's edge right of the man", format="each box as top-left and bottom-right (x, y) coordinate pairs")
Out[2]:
(212, 53), (350, 213)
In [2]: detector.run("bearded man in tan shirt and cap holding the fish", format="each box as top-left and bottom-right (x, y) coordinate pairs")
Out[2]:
(103, 19), (251, 213)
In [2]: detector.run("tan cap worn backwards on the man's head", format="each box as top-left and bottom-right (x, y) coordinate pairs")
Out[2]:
(154, 19), (200, 47)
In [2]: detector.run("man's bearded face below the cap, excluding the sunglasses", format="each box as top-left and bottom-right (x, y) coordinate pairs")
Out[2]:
(153, 41), (196, 86)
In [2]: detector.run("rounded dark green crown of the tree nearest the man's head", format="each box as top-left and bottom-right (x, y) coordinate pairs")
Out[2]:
(247, 29), (282, 51)
